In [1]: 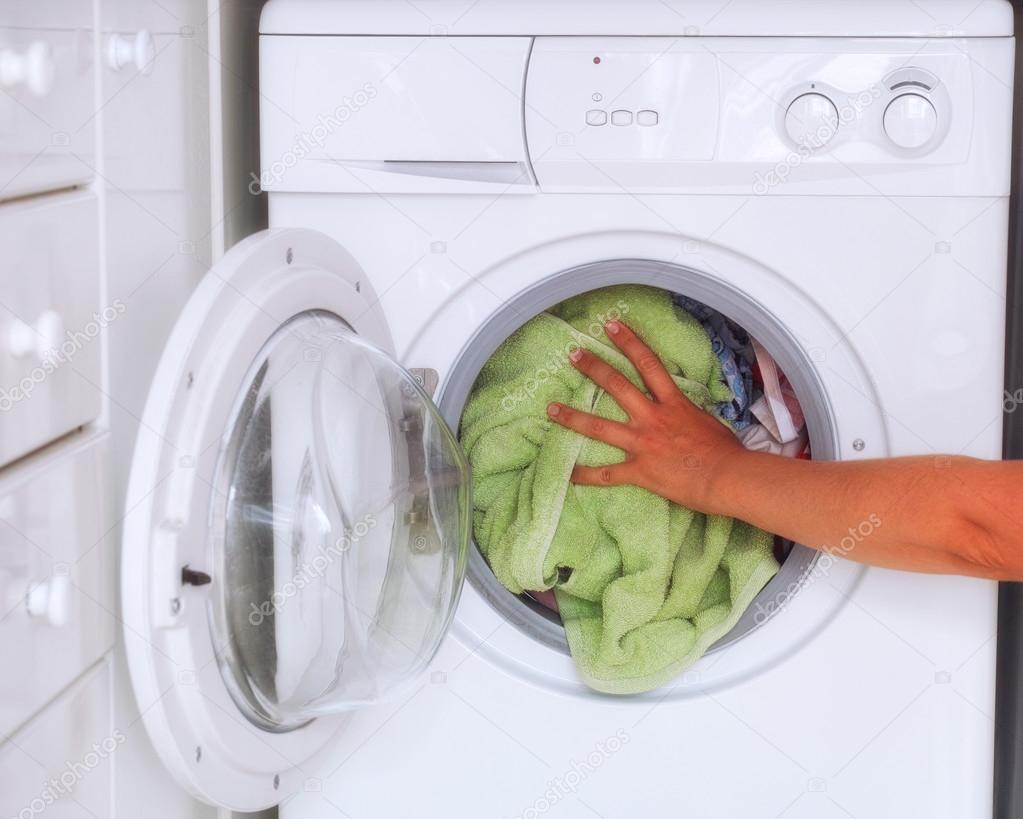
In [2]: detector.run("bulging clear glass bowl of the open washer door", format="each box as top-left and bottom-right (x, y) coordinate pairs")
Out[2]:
(209, 312), (471, 731)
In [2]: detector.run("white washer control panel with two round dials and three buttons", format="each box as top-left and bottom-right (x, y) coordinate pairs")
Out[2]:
(525, 37), (1013, 195)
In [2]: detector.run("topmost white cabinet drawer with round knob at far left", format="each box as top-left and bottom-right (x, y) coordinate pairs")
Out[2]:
(0, 28), (97, 198)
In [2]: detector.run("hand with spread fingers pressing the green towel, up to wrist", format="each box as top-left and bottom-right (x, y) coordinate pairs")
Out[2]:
(547, 321), (746, 513)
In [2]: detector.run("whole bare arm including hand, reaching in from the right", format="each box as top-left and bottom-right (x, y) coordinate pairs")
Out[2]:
(548, 322), (1023, 580)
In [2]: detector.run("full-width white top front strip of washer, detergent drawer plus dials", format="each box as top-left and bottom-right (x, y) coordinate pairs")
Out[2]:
(258, 35), (1014, 196)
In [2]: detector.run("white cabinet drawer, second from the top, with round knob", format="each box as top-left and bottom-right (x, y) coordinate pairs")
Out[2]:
(0, 192), (102, 465)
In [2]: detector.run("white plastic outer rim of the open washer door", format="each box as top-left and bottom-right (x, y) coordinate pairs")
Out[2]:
(121, 229), (394, 811)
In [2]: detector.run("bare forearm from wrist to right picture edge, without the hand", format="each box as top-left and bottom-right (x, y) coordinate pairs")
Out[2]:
(703, 452), (1023, 579)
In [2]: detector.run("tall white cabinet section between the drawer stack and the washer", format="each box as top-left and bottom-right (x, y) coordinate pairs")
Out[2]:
(95, 0), (219, 819)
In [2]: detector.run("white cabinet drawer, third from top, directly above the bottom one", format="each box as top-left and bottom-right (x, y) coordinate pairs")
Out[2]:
(0, 435), (115, 736)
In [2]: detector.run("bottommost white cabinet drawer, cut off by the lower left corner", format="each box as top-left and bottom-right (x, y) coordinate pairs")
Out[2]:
(0, 662), (113, 819)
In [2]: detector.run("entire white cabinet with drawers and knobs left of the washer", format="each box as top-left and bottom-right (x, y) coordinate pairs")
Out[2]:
(0, 0), (237, 819)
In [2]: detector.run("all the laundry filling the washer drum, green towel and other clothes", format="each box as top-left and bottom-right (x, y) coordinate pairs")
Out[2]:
(460, 284), (812, 693)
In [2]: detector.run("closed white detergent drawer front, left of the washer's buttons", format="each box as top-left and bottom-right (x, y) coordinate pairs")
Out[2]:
(259, 36), (535, 193)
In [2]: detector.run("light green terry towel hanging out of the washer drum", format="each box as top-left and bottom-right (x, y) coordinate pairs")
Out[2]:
(461, 285), (777, 694)
